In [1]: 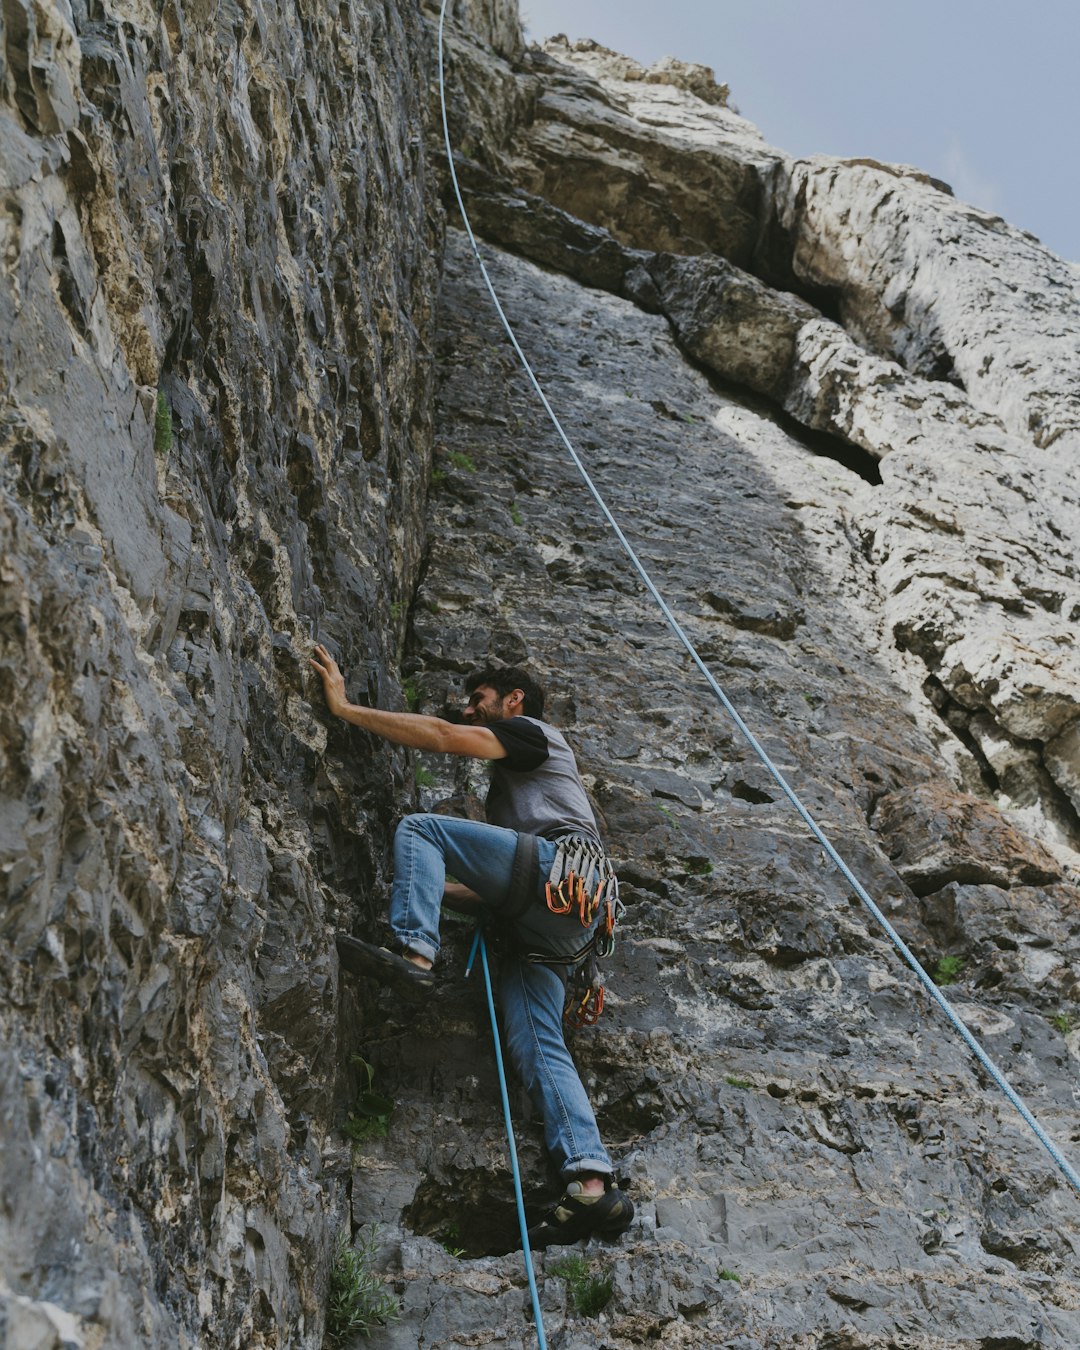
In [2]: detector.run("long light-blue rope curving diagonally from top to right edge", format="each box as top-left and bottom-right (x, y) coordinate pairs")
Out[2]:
(439, 0), (1080, 1195)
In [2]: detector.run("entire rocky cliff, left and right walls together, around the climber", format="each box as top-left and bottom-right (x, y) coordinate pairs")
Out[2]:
(0, 0), (1080, 1350)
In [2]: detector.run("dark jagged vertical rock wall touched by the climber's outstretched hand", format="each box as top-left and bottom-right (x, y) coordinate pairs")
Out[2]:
(0, 0), (441, 1350)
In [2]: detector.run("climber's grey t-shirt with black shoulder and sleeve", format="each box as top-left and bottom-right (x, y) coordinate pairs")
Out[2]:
(486, 717), (599, 842)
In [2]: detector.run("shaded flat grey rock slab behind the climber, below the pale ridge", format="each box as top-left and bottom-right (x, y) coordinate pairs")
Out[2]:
(352, 238), (1080, 1350)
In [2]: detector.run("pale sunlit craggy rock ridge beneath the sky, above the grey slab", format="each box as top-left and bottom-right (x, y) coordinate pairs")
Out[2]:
(448, 29), (1080, 874)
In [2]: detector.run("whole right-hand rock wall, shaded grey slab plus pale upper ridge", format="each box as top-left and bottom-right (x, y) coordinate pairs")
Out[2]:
(340, 10), (1080, 1350)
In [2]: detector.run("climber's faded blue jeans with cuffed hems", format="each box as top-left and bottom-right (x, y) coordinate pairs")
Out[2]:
(390, 815), (612, 1176)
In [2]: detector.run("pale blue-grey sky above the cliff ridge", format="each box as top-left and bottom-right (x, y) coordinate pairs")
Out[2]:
(521, 0), (1080, 261)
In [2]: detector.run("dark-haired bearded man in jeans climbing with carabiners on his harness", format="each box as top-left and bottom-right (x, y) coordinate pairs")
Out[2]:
(311, 645), (633, 1249)
